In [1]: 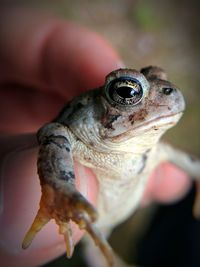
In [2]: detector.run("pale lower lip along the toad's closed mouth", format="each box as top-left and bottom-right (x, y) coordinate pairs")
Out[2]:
(111, 111), (183, 142)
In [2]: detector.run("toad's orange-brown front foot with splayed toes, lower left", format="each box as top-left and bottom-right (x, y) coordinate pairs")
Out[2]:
(22, 185), (112, 266)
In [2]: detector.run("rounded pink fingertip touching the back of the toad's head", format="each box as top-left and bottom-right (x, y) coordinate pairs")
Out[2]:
(43, 22), (124, 98)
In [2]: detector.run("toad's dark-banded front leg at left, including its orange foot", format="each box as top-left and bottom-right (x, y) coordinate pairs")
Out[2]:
(22, 123), (113, 266)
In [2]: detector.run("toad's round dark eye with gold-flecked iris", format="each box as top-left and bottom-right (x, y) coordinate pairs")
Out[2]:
(106, 77), (143, 106)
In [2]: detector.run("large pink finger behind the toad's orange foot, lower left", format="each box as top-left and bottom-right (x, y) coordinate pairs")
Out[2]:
(0, 137), (97, 266)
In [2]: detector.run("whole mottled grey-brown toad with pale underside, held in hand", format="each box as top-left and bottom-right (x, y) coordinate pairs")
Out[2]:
(23, 67), (200, 266)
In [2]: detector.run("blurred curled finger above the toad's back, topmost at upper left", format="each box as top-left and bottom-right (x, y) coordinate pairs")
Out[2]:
(0, 9), (120, 94)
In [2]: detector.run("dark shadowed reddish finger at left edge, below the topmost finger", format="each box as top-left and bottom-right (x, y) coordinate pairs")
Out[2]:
(0, 85), (65, 134)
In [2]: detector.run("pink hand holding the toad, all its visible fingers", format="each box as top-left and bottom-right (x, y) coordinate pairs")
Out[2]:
(0, 8), (190, 267)
